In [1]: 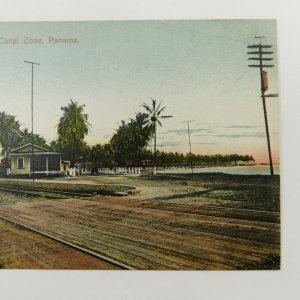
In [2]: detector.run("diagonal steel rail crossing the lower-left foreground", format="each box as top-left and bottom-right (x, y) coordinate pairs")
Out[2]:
(0, 216), (135, 270)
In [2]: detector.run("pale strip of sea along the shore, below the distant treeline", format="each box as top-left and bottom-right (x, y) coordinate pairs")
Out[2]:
(158, 165), (280, 175)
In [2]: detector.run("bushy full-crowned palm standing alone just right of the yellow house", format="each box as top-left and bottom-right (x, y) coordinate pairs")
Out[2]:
(57, 100), (91, 167)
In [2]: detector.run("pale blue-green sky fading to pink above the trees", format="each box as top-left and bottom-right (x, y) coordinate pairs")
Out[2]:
(0, 20), (280, 162)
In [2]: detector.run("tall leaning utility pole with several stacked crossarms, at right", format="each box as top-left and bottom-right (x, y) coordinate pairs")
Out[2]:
(247, 36), (278, 178)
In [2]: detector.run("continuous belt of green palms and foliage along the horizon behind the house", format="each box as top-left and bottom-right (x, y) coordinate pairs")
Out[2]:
(0, 99), (253, 171)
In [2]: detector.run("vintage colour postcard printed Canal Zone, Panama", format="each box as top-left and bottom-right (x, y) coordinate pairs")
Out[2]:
(0, 19), (281, 271)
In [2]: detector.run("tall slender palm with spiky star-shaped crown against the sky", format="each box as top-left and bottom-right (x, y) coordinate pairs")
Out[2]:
(142, 99), (172, 155)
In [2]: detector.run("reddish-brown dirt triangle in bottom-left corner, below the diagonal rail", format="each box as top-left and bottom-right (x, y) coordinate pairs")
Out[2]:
(0, 220), (115, 270)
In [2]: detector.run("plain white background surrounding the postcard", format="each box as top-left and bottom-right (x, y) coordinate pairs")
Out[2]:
(0, 0), (300, 300)
